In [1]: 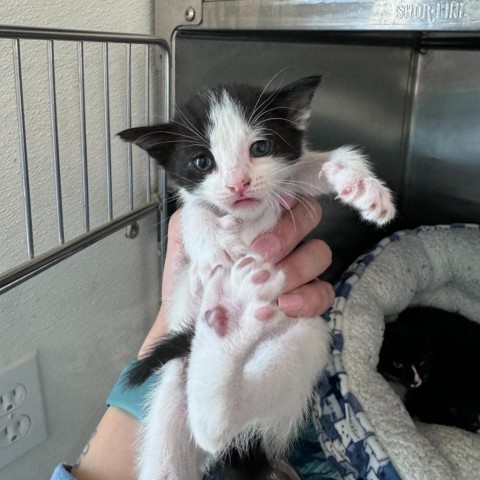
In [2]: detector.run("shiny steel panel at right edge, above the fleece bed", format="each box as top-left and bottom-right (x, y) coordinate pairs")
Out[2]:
(405, 50), (480, 225)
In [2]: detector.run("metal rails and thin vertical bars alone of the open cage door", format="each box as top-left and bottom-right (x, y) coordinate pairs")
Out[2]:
(0, 26), (170, 294)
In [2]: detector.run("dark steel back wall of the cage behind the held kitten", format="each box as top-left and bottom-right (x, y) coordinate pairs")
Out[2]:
(175, 32), (416, 276)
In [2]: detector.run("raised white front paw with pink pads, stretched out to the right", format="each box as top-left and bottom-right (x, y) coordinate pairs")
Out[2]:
(319, 147), (395, 225)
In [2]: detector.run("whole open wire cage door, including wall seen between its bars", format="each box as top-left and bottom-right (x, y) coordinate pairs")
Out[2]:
(0, 27), (169, 294)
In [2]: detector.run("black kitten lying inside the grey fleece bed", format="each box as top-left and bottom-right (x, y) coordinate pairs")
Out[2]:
(378, 307), (480, 433)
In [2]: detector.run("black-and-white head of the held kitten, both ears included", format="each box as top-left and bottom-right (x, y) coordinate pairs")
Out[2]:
(119, 77), (320, 218)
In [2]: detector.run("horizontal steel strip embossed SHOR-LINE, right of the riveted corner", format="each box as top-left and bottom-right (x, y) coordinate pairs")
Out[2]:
(198, 0), (480, 31)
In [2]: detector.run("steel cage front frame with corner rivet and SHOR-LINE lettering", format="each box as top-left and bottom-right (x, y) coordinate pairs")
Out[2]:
(155, 0), (480, 114)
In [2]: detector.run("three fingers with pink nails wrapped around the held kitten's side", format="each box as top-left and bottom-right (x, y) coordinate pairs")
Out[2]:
(252, 198), (335, 317)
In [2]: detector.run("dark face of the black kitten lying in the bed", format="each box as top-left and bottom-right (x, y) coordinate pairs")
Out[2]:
(378, 322), (429, 388)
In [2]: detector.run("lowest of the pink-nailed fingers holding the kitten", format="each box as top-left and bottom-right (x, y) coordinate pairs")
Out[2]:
(278, 280), (335, 318)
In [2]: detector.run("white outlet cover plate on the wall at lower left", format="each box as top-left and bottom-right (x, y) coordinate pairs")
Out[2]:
(0, 353), (47, 469)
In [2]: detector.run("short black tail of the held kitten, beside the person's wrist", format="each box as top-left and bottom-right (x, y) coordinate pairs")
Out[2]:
(125, 330), (193, 387)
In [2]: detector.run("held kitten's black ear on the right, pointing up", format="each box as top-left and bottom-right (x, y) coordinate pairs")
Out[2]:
(276, 75), (322, 130)
